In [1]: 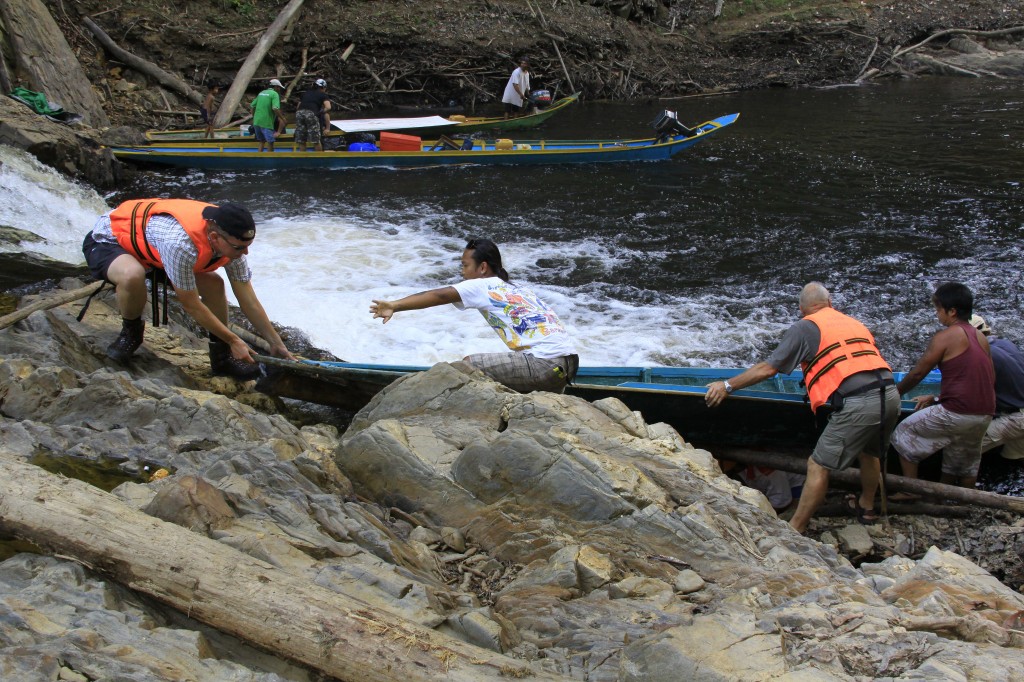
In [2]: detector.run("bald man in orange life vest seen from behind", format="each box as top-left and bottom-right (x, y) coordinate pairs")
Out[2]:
(705, 282), (899, 532)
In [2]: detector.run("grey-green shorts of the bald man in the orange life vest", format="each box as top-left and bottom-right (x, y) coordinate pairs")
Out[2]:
(811, 386), (899, 471)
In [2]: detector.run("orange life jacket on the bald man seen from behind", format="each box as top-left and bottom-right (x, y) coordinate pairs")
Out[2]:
(801, 308), (889, 412)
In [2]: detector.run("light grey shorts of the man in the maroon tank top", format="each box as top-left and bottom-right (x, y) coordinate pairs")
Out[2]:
(893, 404), (992, 476)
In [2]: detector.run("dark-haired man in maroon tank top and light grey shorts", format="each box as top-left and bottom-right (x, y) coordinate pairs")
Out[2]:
(892, 282), (995, 493)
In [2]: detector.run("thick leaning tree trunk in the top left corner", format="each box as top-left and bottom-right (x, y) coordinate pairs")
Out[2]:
(0, 0), (111, 128)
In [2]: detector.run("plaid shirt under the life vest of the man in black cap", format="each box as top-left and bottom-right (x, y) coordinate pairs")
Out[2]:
(92, 213), (253, 291)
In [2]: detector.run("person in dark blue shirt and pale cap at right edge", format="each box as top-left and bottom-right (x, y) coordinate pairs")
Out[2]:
(970, 315), (1024, 460)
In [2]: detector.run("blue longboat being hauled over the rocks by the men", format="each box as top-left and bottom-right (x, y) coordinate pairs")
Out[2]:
(256, 357), (941, 445)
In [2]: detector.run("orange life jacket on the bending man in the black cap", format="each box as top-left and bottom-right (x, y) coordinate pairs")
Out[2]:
(111, 199), (230, 272)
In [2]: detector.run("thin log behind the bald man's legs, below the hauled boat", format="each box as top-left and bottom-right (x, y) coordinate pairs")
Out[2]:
(717, 447), (1024, 514)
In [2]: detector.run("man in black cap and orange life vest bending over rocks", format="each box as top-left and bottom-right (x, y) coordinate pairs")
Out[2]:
(82, 199), (294, 379)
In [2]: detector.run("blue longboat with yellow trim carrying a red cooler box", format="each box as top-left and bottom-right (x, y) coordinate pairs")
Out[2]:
(110, 114), (739, 170)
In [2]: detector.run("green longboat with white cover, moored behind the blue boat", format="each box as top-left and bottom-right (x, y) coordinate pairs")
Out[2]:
(145, 92), (580, 143)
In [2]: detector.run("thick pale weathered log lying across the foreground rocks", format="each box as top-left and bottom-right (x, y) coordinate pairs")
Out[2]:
(0, 450), (564, 682)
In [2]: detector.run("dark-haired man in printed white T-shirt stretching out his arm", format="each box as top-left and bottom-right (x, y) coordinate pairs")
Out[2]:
(370, 240), (580, 393)
